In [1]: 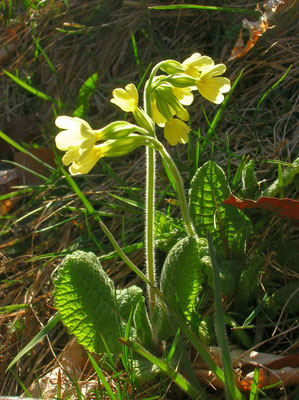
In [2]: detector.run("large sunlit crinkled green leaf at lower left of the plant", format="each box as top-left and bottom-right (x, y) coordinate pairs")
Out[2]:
(54, 251), (135, 353)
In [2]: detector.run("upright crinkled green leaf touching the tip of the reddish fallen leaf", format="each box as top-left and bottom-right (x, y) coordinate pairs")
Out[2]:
(189, 161), (251, 257)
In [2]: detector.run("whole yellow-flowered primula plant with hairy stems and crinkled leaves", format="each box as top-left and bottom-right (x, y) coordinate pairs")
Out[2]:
(54, 53), (254, 388)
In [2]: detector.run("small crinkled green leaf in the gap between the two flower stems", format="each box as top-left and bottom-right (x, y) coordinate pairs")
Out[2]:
(155, 211), (186, 252)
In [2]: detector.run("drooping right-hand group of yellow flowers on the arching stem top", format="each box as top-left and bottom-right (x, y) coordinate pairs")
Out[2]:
(152, 53), (230, 146)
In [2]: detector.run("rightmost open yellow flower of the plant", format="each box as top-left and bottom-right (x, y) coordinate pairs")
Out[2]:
(196, 62), (230, 104)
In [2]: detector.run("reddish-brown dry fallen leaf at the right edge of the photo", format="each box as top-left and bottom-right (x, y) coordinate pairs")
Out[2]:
(224, 194), (299, 221)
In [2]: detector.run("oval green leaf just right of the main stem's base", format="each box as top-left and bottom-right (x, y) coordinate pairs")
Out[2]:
(160, 236), (209, 321)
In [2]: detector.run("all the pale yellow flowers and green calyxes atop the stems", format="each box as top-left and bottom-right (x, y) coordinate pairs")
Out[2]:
(56, 53), (230, 174)
